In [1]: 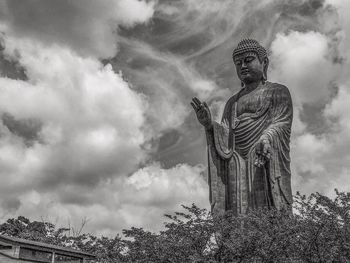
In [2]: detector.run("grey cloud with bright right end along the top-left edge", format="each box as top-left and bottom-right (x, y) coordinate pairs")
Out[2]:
(0, 0), (154, 58)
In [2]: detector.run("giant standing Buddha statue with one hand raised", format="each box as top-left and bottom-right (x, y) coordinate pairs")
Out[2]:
(191, 39), (293, 214)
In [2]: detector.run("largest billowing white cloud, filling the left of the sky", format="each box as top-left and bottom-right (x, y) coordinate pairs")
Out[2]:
(0, 35), (147, 194)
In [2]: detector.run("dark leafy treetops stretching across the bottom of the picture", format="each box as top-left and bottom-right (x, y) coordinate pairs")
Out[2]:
(0, 191), (350, 263)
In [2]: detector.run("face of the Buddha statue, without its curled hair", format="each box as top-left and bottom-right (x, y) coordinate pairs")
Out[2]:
(234, 52), (264, 84)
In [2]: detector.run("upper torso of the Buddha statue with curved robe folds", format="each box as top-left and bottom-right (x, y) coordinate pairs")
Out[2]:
(223, 82), (292, 161)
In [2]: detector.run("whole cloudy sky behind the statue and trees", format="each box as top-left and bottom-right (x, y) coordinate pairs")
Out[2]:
(0, 0), (350, 235)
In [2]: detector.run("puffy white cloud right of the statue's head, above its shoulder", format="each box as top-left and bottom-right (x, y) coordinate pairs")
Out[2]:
(271, 31), (337, 103)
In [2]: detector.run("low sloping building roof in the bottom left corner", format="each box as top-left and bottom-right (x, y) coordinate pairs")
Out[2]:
(0, 235), (95, 258)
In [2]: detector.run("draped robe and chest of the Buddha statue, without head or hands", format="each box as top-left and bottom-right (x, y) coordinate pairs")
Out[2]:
(207, 82), (293, 217)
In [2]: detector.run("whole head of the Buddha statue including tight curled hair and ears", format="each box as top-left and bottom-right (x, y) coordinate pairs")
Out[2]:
(232, 39), (269, 85)
